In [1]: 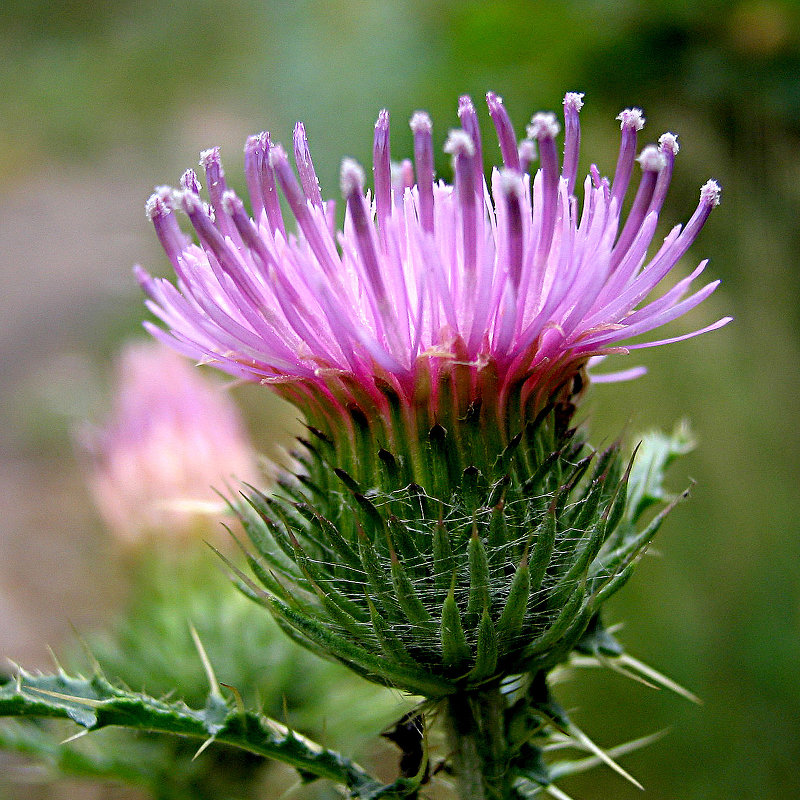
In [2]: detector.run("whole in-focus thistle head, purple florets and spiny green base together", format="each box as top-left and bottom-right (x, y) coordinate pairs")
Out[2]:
(137, 93), (728, 700)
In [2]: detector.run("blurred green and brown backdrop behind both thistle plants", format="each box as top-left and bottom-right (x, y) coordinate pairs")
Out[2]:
(0, 0), (800, 800)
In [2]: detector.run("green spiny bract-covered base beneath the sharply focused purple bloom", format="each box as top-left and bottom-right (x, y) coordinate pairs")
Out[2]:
(233, 382), (661, 698)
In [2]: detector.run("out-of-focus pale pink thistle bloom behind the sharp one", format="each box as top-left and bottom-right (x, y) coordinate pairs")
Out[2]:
(79, 342), (258, 543)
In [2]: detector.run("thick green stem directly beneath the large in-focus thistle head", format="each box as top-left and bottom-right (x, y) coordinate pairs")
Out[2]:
(446, 687), (511, 800)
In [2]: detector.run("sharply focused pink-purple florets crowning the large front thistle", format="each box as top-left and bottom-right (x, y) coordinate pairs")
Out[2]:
(137, 92), (730, 428)
